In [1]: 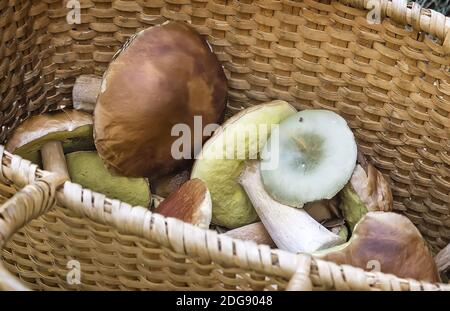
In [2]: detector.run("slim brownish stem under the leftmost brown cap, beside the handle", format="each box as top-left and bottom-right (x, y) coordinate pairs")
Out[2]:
(41, 140), (70, 183)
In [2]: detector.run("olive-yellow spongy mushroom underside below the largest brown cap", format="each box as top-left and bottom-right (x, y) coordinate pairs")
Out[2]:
(66, 151), (152, 208)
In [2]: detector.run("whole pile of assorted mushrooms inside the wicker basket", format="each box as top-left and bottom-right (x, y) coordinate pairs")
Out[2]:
(7, 22), (439, 282)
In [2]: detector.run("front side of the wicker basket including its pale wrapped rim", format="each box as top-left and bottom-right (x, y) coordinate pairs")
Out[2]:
(0, 152), (450, 290)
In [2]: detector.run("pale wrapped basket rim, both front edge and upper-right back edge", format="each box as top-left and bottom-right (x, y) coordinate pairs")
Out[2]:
(0, 0), (450, 290)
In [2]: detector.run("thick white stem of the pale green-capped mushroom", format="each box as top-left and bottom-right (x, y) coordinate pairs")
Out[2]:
(239, 161), (345, 253)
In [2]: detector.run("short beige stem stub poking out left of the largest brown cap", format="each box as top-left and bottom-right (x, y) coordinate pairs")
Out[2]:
(72, 75), (102, 112)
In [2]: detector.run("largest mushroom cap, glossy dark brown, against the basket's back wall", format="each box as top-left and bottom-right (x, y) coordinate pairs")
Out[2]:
(94, 22), (227, 178)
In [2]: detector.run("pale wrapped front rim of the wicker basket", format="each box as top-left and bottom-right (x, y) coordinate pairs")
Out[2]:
(0, 145), (450, 291)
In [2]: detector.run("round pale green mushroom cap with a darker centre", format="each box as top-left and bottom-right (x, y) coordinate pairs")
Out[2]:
(260, 110), (357, 207)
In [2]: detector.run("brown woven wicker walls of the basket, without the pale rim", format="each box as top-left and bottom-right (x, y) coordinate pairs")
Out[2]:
(0, 0), (450, 289)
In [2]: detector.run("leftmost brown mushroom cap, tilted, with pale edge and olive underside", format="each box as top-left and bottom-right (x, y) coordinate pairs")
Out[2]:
(6, 110), (94, 164)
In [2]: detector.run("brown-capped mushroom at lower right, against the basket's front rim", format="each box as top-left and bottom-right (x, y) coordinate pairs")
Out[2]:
(313, 212), (440, 282)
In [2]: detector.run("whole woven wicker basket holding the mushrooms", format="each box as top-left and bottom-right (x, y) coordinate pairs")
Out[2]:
(0, 0), (450, 290)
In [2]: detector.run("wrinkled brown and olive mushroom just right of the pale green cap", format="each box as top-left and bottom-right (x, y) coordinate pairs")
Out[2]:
(340, 164), (393, 230)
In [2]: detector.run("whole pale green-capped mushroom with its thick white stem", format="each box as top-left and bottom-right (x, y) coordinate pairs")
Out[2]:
(239, 110), (357, 253)
